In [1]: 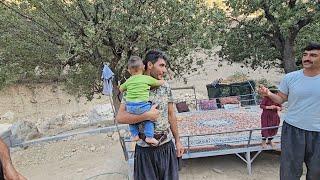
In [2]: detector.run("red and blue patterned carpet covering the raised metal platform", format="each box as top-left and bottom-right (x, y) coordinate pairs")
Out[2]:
(177, 106), (274, 149)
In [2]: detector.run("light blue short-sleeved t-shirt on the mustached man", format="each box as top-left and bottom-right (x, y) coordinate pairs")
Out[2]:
(279, 70), (320, 132)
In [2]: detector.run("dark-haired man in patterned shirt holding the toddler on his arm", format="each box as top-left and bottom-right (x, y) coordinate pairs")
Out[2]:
(116, 50), (184, 180)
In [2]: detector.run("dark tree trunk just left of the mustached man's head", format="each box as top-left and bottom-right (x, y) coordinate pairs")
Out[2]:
(282, 40), (297, 73)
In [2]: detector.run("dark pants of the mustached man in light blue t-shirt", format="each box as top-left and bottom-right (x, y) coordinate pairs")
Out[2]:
(280, 122), (320, 180)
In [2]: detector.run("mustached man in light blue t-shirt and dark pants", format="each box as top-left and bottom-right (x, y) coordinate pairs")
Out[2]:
(259, 43), (320, 180)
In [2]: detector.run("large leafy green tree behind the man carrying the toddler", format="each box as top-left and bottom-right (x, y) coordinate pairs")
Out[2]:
(0, 0), (222, 98)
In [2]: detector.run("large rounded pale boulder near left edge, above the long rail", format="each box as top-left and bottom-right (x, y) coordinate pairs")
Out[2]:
(11, 120), (41, 144)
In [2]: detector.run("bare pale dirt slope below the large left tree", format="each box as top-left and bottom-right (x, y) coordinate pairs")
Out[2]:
(0, 84), (109, 123)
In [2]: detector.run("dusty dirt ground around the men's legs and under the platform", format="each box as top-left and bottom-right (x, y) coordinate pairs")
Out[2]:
(12, 134), (308, 180)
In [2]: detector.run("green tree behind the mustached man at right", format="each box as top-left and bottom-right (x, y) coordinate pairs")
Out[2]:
(220, 0), (320, 73)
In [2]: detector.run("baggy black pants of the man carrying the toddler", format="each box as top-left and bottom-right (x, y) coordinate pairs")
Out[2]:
(134, 141), (179, 180)
